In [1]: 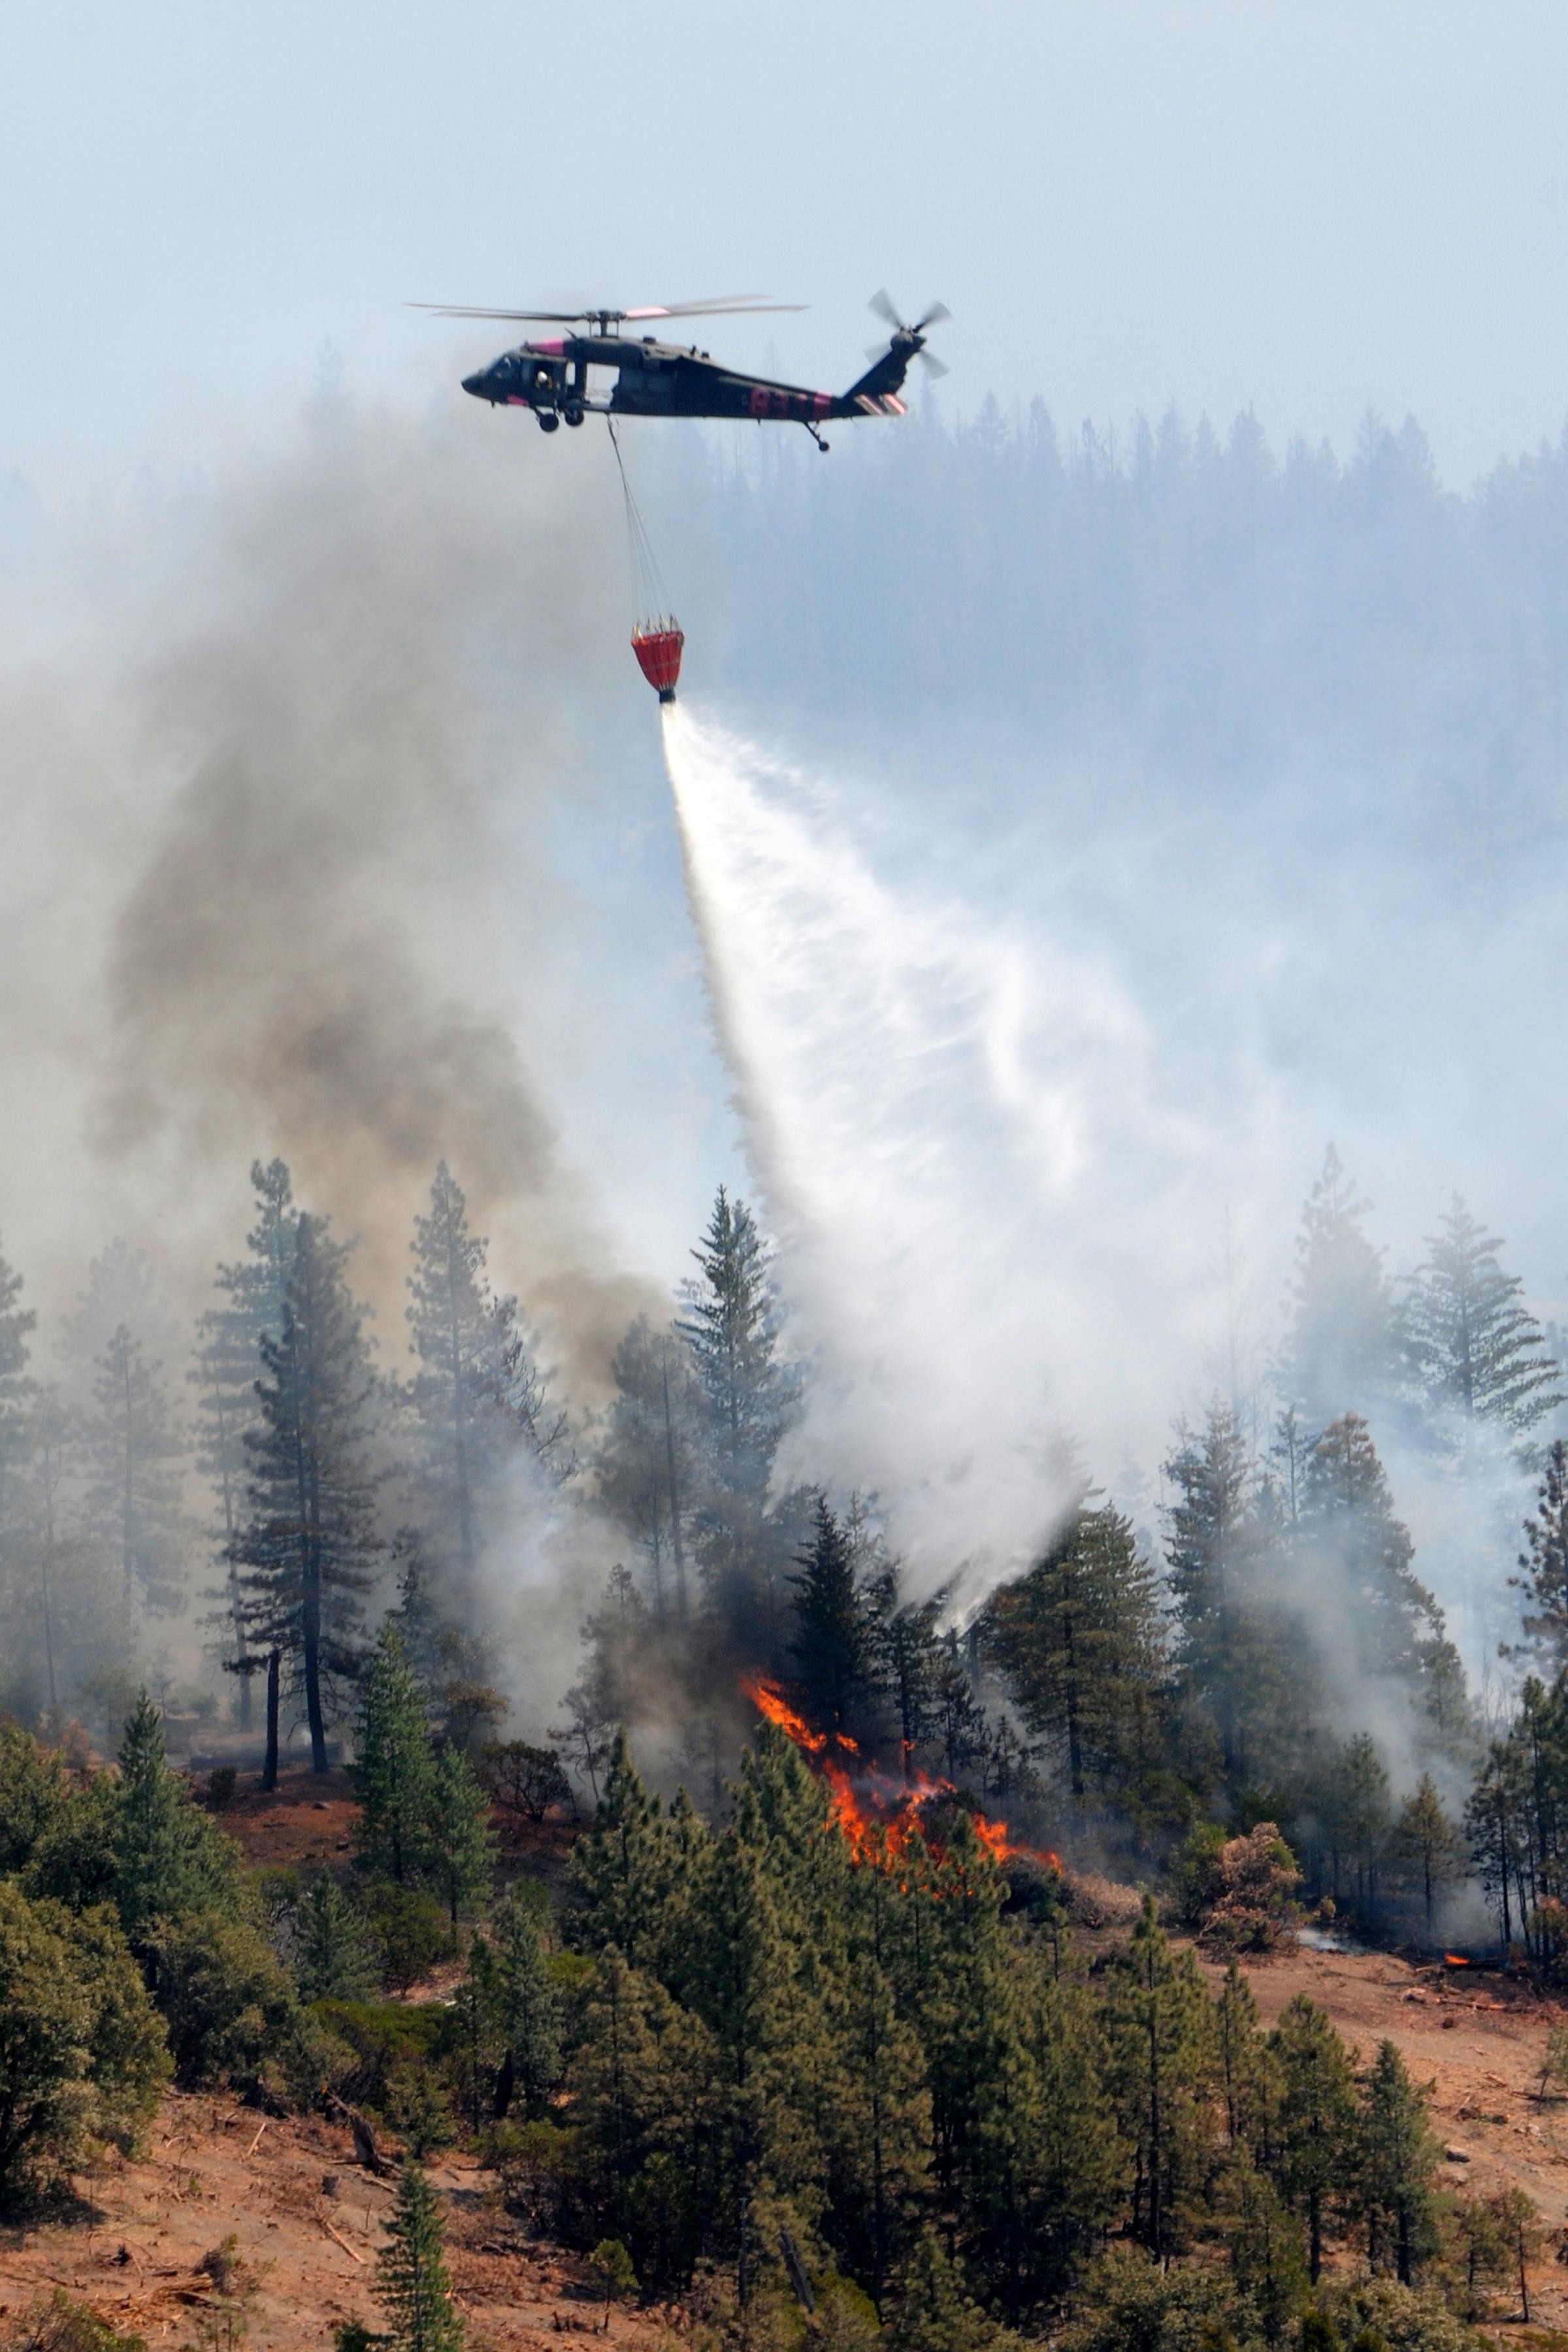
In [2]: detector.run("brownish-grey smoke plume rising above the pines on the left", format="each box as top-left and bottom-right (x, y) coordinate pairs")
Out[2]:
(0, 393), (662, 1390)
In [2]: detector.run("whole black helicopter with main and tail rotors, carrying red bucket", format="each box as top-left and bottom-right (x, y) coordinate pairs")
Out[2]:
(412, 291), (952, 451)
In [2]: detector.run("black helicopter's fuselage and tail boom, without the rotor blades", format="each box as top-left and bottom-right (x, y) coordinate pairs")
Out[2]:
(463, 334), (919, 428)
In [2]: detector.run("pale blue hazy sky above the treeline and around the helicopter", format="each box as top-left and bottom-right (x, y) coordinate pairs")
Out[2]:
(0, 0), (1568, 485)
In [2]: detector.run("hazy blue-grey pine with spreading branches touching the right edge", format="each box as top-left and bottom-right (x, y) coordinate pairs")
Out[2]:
(1406, 1192), (1568, 1437)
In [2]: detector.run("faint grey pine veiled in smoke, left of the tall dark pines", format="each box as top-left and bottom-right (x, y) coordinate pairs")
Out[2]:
(85, 1324), (186, 1625)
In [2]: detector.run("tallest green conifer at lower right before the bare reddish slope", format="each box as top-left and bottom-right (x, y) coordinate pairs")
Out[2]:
(1105, 1896), (1213, 2262)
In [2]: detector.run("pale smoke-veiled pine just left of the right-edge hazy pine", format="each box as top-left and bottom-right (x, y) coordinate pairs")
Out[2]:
(1284, 1143), (1396, 1428)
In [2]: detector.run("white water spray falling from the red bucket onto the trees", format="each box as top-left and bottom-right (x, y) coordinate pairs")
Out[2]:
(661, 706), (1175, 1614)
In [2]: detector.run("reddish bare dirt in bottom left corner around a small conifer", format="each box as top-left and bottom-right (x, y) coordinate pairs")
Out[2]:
(0, 2093), (670, 2352)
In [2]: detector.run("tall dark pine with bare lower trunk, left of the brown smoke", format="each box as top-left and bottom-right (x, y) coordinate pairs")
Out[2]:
(240, 1214), (384, 1771)
